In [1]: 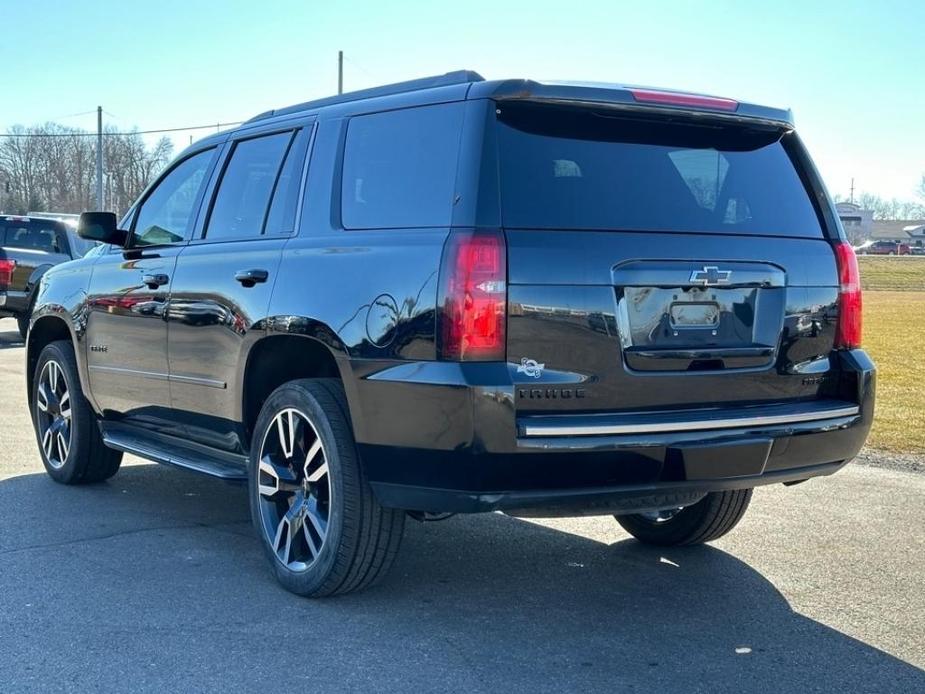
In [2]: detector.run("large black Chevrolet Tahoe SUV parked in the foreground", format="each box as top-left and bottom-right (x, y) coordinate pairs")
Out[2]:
(27, 72), (874, 596)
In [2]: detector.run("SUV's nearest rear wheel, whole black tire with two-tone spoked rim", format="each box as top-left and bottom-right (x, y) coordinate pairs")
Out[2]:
(249, 379), (405, 598)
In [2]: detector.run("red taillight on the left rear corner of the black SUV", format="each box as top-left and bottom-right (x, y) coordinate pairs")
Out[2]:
(437, 229), (507, 361)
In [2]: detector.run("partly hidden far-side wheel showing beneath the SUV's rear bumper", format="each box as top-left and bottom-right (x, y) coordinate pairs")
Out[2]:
(614, 489), (752, 546)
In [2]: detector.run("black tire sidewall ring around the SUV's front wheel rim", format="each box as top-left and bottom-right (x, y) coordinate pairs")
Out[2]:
(32, 342), (87, 484)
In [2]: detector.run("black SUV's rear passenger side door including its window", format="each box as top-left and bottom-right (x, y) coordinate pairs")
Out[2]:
(168, 123), (312, 452)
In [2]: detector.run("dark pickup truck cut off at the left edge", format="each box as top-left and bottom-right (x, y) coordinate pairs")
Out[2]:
(0, 215), (97, 337)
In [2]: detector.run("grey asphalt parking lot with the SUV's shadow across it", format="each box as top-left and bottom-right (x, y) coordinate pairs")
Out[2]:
(0, 320), (925, 692)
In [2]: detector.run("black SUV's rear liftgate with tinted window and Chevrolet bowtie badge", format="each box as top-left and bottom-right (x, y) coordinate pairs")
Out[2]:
(497, 103), (838, 412)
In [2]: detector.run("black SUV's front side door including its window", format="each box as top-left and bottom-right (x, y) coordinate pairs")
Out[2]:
(86, 148), (215, 425)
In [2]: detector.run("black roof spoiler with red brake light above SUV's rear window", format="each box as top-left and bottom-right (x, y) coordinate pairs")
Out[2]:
(467, 80), (794, 130)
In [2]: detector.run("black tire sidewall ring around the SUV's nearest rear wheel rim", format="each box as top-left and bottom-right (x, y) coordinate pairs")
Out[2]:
(248, 383), (354, 594)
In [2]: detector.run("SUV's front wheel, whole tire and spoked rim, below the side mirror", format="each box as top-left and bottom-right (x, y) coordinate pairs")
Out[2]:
(32, 340), (122, 484)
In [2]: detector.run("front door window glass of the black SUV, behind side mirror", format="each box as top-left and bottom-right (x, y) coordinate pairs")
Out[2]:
(131, 149), (214, 248)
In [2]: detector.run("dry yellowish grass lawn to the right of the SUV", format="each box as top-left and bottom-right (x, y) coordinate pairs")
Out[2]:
(861, 290), (925, 454)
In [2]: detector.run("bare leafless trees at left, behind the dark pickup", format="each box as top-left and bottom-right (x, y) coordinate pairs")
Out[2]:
(0, 123), (173, 216)
